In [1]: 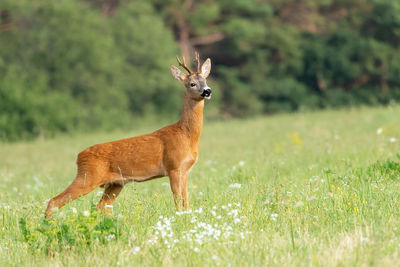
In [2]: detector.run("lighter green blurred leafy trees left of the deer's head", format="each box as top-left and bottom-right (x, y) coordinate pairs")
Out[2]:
(0, 0), (180, 139)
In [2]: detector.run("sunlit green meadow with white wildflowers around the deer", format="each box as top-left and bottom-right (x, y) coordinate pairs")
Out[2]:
(0, 106), (400, 266)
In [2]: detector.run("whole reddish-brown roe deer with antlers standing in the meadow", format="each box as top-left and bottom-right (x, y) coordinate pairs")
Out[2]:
(46, 53), (211, 218)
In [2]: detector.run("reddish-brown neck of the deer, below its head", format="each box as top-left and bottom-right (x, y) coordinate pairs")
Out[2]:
(178, 91), (204, 143)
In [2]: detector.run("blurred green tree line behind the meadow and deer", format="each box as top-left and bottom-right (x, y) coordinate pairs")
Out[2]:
(0, 0), (400, 140)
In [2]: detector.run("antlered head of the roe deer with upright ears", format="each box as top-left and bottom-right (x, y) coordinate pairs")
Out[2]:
(171, 52), (211, 100)
